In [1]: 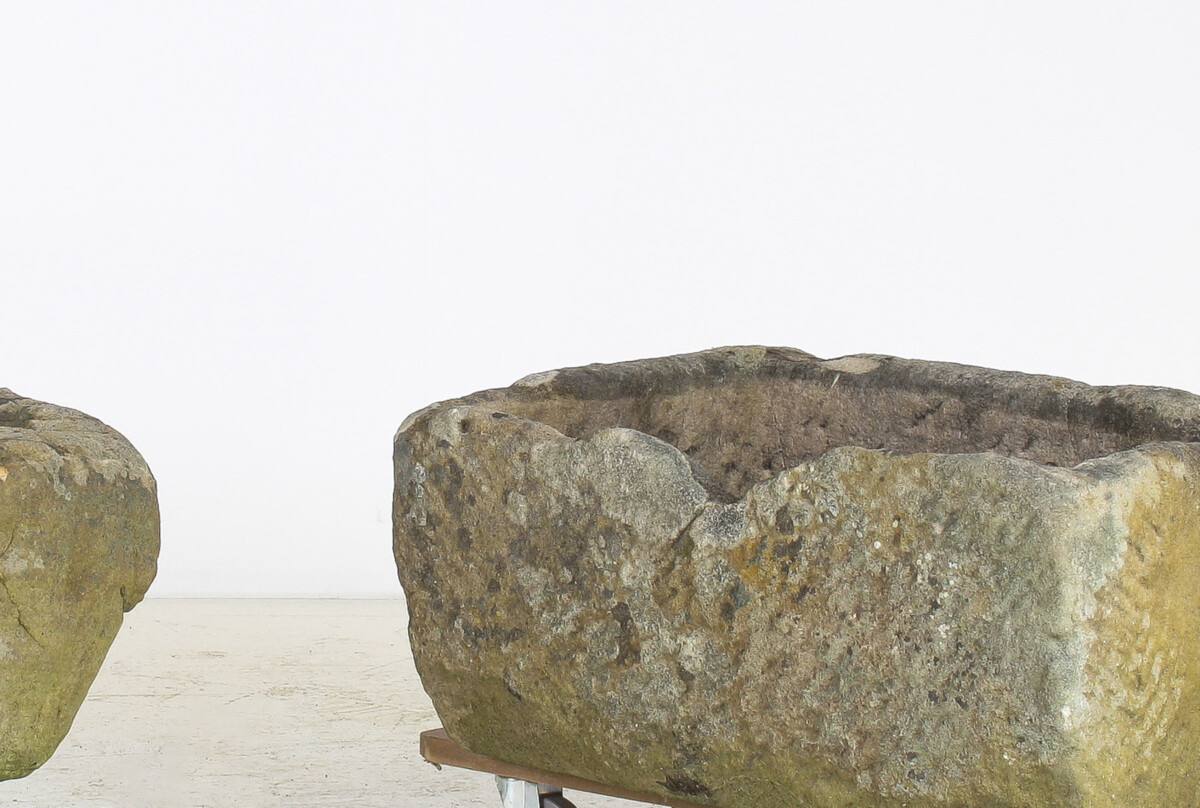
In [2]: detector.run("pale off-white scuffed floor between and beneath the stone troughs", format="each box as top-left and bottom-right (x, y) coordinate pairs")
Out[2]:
(0, 599), (640, 808)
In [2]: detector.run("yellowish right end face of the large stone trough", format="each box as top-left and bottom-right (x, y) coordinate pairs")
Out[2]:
(1079, 450), (1200, 808)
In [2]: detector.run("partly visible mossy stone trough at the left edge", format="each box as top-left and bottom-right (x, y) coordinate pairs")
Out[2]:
(0, 388), (158, 779)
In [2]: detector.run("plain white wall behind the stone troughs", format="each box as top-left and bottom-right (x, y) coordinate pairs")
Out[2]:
(0, 0), (1200, 595)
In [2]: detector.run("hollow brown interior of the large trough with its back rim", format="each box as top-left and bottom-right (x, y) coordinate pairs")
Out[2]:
(463, 348), (1200, 501)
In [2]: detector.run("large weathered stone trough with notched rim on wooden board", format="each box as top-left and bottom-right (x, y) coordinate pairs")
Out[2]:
(394, 347), (1200, 808)
